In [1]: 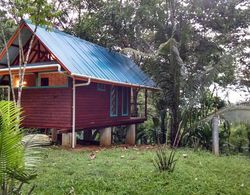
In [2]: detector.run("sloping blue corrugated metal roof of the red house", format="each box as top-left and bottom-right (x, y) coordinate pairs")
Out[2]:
(25, 21), (155, 88)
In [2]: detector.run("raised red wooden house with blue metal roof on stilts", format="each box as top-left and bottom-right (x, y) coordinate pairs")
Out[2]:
(0, 21), (155, 147)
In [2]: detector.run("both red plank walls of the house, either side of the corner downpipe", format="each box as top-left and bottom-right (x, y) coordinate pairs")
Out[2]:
(19, 83), (130, 130)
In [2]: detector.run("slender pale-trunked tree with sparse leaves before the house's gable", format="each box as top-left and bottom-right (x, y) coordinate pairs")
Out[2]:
(0, 0), (59, 106)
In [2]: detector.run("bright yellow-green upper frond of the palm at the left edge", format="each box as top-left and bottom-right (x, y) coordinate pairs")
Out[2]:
(0, 101), (24, 183)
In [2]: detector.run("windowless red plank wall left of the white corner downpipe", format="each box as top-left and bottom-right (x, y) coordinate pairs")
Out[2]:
(22, 88), (72, 129)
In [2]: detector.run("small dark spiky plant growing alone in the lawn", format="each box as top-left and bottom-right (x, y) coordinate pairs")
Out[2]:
(153, 146), (177, 172)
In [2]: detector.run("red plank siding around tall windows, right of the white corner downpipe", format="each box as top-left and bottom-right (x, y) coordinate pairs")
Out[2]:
(76, 83), (130, 129)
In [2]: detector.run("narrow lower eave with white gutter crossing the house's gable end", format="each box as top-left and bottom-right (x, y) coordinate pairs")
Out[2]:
(0, 64), (61, 75)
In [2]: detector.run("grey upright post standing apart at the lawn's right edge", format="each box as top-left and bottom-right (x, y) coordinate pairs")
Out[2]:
(212, 116), (220, 156)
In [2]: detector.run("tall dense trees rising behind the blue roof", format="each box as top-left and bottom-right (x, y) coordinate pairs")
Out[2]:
(0, 0), (250, 147)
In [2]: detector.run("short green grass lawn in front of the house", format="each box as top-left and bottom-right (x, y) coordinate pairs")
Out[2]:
(23, 147), (250, 195)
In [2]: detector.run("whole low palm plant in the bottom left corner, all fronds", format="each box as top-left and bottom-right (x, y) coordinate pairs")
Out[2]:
(0, 101), (38, 195)
